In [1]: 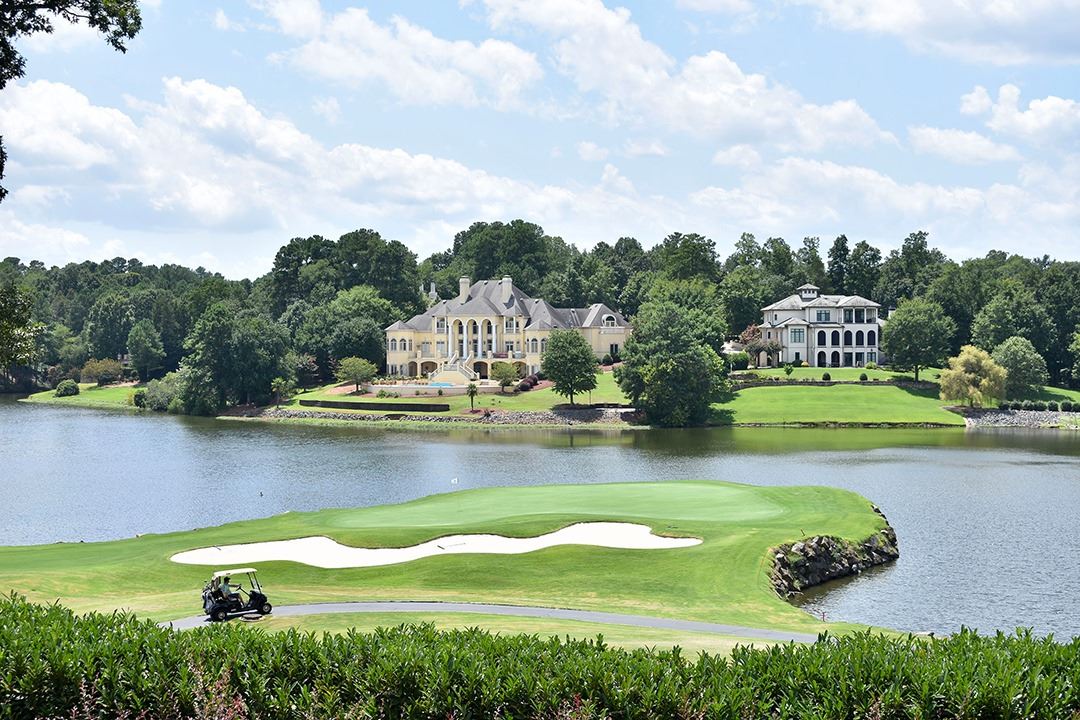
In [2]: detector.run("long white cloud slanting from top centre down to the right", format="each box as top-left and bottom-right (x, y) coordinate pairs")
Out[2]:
(470, 0), (894, 150)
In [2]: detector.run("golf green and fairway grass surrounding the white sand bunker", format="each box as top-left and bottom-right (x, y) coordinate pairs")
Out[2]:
(0, 481), (883, 631)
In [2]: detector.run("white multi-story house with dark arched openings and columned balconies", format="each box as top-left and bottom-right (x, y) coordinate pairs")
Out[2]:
(757, 284), (885, 367)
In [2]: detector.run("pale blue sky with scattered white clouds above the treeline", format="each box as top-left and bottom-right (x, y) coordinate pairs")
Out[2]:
(0, 0), (1080, 277)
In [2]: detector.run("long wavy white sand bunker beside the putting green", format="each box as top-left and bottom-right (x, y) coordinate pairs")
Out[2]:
(172, 522), (701, 568)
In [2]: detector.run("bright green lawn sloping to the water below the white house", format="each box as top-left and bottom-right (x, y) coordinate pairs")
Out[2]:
(713, 385), (964, 425)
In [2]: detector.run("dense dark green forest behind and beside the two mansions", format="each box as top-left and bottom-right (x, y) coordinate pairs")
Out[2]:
(0, 220), (1080, 412)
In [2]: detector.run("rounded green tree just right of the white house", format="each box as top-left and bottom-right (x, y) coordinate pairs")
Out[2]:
(881, 298), (956, 382)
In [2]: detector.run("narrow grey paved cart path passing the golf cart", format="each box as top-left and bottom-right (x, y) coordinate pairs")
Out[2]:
(159, 600), (818, 642)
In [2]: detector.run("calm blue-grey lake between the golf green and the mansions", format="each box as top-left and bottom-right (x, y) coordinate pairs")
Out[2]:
(0, 395), (1080, 638)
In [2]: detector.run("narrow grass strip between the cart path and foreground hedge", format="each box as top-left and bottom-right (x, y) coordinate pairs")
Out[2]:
(256, 612), (772, 655)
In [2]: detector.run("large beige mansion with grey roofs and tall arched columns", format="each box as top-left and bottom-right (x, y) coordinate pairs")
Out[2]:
(387, 276), (631, 380)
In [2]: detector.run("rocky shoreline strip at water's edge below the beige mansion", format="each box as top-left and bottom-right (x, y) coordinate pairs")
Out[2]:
(252, 408), (640, 425)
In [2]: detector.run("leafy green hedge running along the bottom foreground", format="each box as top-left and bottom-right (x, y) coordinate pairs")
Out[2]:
(0, 598), (1080, 720)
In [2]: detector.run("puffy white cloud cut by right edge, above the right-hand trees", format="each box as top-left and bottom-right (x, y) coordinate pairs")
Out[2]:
(961, 84), (1080, 146)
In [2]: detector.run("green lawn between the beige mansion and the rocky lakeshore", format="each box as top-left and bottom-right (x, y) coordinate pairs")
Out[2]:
(289, 372), (627, 415)
